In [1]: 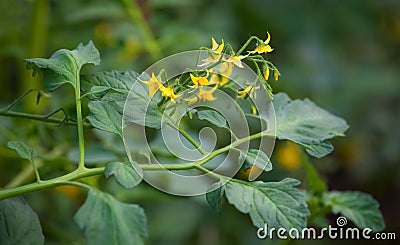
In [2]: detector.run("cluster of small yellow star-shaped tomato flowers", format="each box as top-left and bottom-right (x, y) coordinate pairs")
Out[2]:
(143, 32), (280, 112)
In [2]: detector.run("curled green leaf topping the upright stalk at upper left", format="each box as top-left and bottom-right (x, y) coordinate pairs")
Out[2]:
(26, 41), (100, 91)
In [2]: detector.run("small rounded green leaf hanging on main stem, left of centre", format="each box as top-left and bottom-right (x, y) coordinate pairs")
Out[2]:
(104, 162), (143, 189)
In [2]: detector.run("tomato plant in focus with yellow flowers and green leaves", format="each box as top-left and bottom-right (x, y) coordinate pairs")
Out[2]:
(0, 33), (384, 244)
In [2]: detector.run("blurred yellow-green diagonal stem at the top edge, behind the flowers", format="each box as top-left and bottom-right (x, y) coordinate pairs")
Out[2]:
(121, 0), (161, 60)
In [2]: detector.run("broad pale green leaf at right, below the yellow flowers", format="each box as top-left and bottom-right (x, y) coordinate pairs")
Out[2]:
(270, 93), (349, 157)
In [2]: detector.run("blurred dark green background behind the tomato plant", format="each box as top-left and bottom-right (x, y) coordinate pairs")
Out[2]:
(0, 0), (400, 245)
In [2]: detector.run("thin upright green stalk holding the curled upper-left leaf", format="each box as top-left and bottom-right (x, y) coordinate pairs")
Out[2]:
(75, 72), (85, 169)
